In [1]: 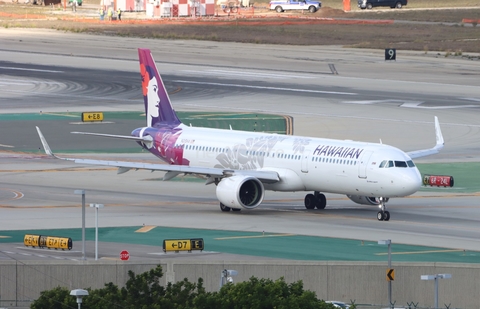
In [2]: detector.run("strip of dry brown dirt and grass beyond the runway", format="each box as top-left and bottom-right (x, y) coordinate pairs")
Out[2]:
(0, 4), (480, 56)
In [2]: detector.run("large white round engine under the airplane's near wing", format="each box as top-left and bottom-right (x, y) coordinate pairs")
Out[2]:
(217, 175), (265, 209)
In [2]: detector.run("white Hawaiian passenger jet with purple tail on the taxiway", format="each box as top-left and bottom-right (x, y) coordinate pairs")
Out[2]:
(37, 48), (444, 221)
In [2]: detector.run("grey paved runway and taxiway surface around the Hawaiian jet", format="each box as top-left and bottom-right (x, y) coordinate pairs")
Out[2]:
(0, 29), (480, 255)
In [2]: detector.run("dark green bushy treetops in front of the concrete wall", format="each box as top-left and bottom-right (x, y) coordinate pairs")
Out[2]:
(30, 266), (333, 309)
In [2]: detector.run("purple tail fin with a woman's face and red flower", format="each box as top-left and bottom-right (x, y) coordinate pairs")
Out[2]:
(138, 48), (181, 127)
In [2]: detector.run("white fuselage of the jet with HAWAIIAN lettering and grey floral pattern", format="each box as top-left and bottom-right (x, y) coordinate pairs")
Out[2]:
(155, 125), (421, 197)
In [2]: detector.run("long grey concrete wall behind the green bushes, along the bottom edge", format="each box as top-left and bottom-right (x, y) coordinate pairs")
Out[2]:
(0, 260), (480, 309)
